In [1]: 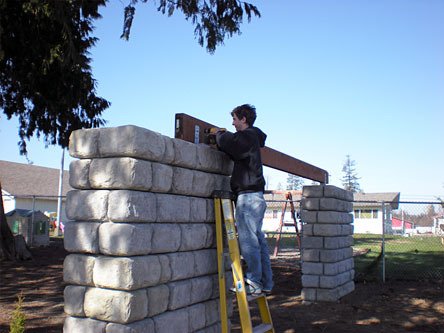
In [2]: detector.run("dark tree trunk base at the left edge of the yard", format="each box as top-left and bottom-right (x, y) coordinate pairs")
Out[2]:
(0, 182), (32, 261)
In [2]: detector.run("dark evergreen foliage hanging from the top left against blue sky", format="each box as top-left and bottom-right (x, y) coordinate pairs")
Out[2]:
(0, 0), (260, 155)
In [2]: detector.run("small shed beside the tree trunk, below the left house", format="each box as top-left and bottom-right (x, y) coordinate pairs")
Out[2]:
(5, 209), (49, 247)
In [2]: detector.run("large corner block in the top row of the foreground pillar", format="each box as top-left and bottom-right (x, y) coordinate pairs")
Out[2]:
(99, 125), (165, 161)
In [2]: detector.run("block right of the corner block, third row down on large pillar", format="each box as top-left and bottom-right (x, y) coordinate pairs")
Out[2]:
(156, 194), (191, 223)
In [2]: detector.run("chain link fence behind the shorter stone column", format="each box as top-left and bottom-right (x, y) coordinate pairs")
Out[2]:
(263, 198), (444, 281)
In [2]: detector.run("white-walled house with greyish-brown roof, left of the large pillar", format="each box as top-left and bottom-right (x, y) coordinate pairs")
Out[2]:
(0, 161), (72, 227)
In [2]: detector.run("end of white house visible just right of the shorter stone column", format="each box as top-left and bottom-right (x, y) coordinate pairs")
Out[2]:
(353, 192), (400, 234)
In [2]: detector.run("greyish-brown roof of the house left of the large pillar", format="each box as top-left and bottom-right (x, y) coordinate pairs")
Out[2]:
(0, 161), (72, 196)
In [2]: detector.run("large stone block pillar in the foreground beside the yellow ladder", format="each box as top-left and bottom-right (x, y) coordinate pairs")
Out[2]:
(63, 126), (236, 333)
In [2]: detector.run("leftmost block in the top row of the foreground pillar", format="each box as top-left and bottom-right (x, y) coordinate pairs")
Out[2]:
(69, 128), (100, 158)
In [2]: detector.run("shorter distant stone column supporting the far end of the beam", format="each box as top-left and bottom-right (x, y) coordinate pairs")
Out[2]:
(301, 185), (355, 302)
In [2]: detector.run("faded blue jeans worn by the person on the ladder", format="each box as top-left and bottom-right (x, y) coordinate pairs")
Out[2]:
(235, 192), (273, 290)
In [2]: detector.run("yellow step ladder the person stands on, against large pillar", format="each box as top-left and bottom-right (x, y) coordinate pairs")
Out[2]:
(213, 191), (275, 333)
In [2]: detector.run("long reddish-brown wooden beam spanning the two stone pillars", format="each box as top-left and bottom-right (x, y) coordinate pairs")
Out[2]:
(174, 113), (328, 184)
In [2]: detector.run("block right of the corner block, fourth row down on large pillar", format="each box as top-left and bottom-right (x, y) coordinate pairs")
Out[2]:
(151, 223), (181, 253)
